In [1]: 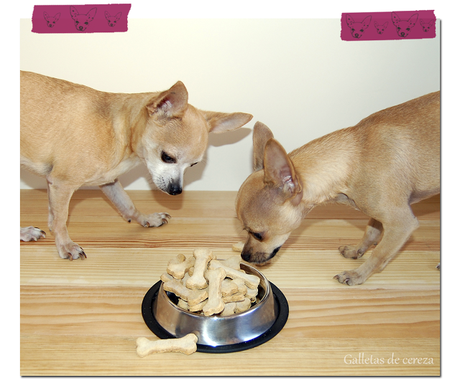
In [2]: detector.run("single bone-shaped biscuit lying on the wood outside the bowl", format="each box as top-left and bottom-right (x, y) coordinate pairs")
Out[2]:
(136, 333), (198, 358)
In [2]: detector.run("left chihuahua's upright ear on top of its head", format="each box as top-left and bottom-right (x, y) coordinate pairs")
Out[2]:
(147, 81), (188, 118)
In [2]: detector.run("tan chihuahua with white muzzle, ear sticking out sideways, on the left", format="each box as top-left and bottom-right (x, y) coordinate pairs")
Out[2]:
(21, 72), (252, 260)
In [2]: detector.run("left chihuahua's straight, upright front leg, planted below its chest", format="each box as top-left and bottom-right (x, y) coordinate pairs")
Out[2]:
(48, 183), (86, 260)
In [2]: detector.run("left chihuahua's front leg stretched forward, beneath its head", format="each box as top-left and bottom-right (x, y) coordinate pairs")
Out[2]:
(100, 180), (171, 227)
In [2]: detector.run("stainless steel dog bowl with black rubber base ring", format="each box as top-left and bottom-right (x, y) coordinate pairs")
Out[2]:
(142, 263), (289, 352)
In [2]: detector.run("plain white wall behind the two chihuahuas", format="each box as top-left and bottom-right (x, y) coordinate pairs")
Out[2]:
(20, 15), (441, 190)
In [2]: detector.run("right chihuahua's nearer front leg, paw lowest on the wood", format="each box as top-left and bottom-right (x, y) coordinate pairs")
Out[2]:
(334, 206), (419, 286)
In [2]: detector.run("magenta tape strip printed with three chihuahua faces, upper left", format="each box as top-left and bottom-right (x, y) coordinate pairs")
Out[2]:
(32, 4), (131, 33)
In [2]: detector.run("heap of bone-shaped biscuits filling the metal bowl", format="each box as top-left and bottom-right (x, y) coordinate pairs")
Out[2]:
(161, 248), (260, 316)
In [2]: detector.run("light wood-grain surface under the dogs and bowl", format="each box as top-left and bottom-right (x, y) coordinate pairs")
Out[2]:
(20, 190), (440, 376)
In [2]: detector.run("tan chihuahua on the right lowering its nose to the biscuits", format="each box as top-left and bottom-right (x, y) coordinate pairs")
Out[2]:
(236, 92), (440, 285)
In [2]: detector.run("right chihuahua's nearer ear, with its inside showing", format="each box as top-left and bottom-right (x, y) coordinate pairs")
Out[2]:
(264, 138), (303, 205)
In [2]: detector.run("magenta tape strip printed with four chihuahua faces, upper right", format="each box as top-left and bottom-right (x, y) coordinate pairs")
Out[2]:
(340, 11), (436, 41)
